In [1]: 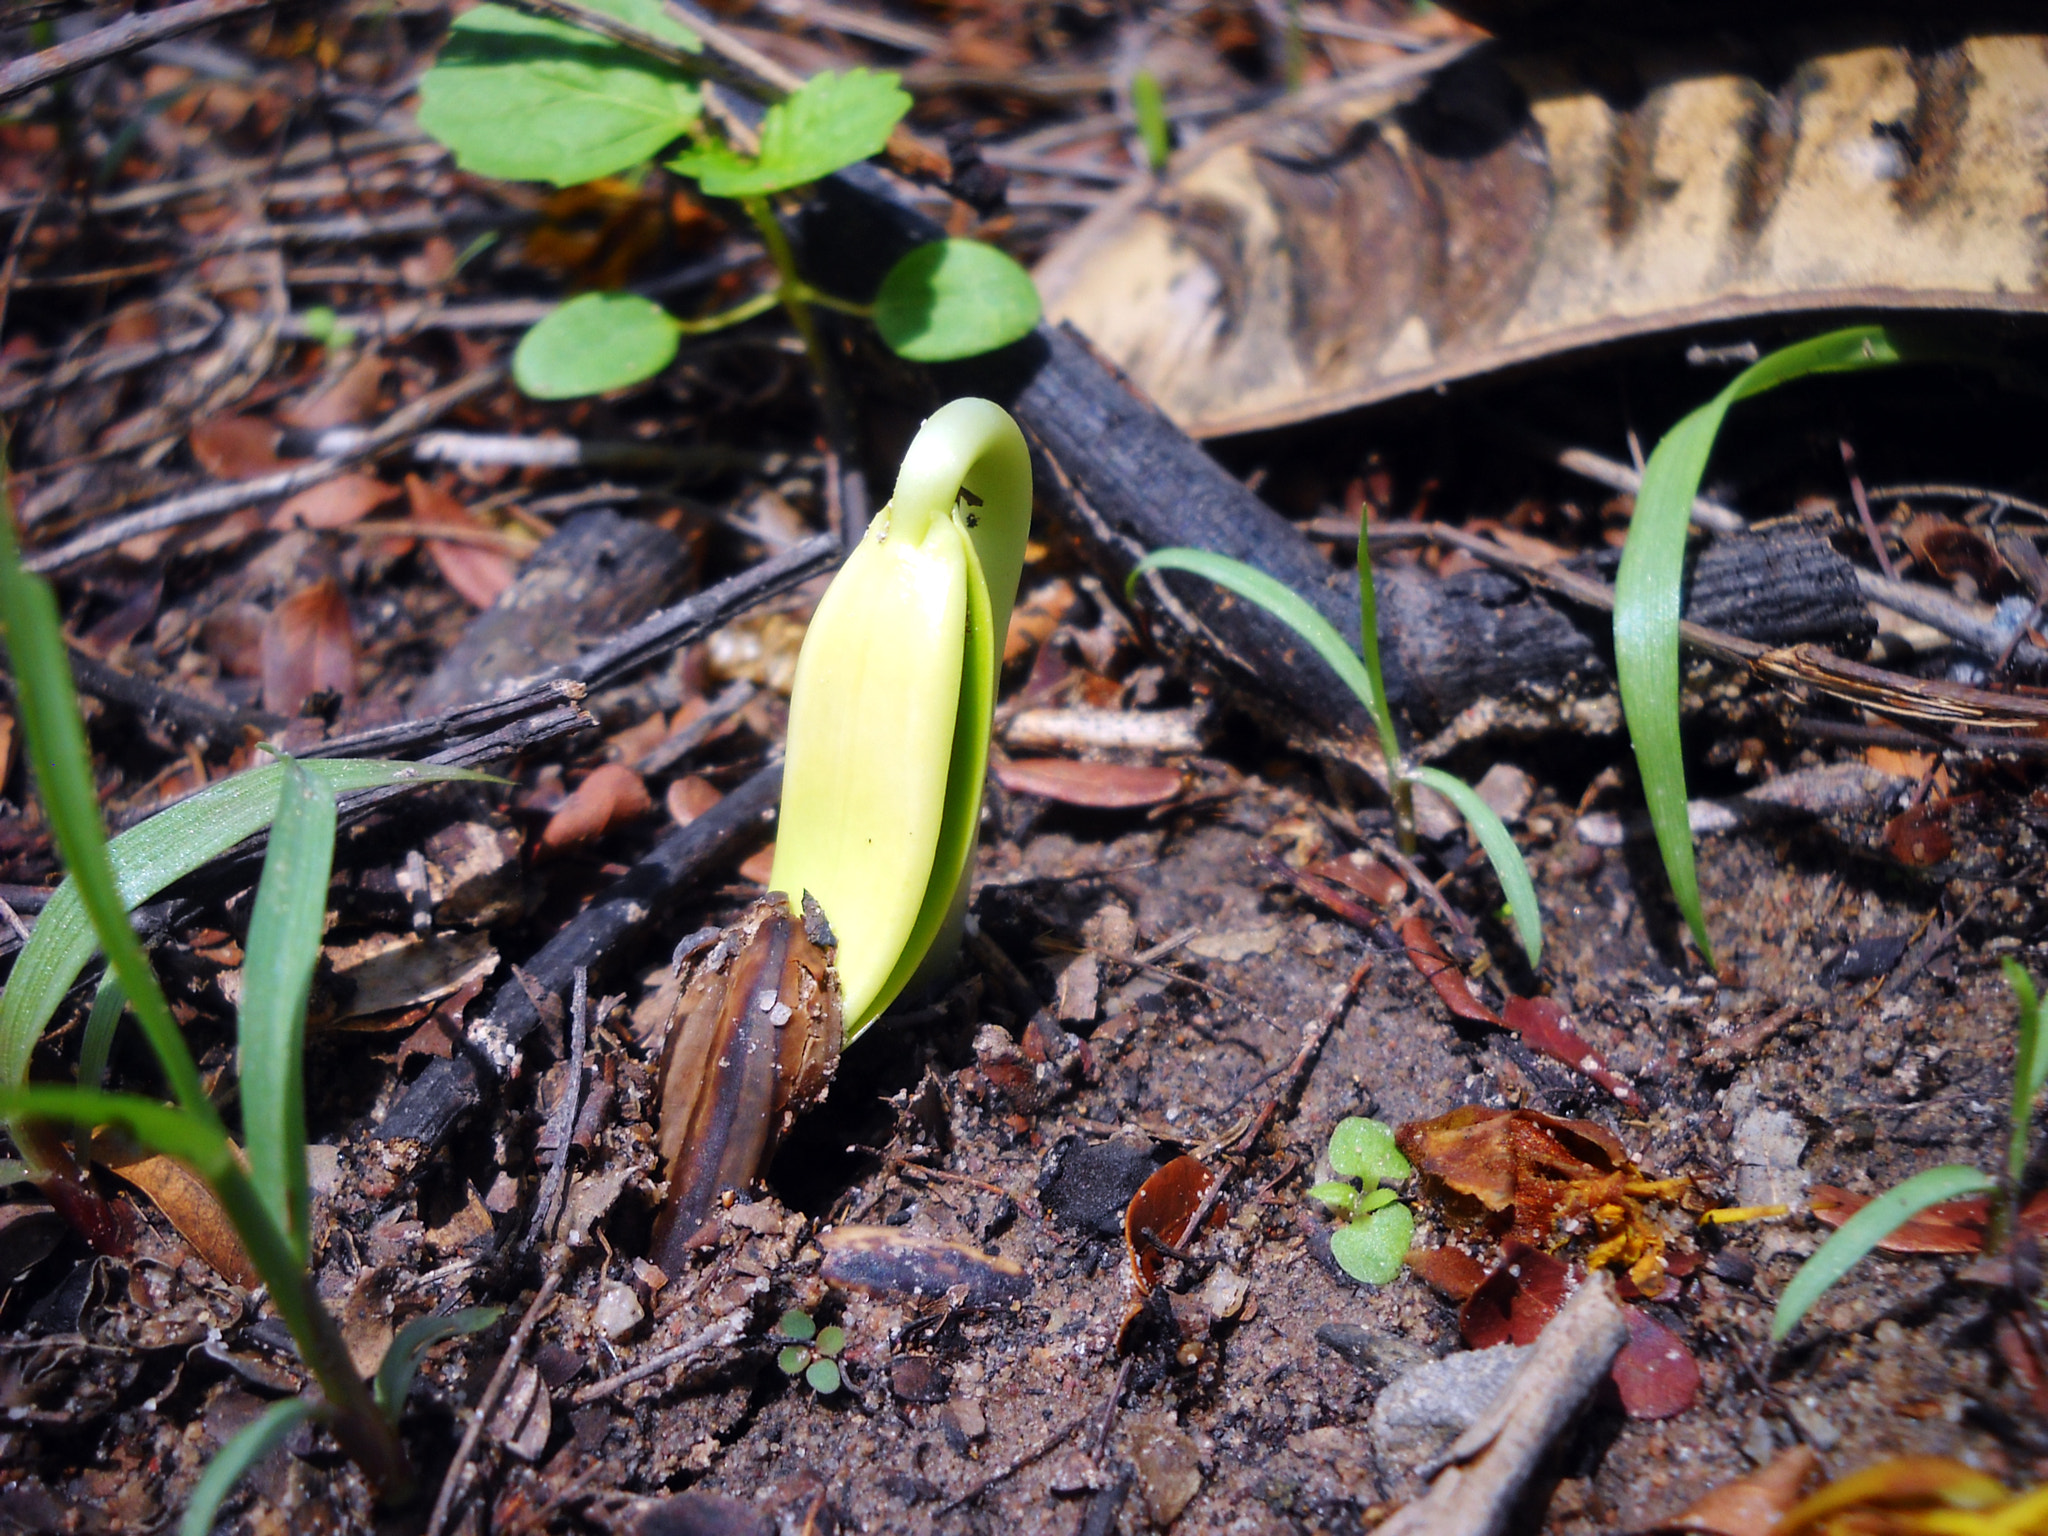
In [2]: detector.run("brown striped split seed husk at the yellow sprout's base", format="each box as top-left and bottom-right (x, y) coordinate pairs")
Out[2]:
(651, 895), (842, 1274)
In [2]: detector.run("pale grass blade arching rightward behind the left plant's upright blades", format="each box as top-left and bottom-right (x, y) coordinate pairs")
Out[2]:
(0, 758), (487, 1130)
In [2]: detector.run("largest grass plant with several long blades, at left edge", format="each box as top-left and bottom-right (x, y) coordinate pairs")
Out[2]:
(0, 485), (498, 1536)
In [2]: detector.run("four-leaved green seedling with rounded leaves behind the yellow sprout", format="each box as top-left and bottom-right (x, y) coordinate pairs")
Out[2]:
(420, 0), (1038, 399)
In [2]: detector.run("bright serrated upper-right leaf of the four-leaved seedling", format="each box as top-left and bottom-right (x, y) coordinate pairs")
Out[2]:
(668, 70), (911, 197)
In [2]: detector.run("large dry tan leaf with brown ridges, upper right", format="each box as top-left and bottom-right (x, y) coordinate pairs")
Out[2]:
(1036, 25), (2048, 436)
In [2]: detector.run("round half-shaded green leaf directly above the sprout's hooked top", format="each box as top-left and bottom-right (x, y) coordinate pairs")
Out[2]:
(874, 240), (1038, 362)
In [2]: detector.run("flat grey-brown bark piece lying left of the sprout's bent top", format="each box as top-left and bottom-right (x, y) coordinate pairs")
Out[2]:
(412, 508), (688, 713)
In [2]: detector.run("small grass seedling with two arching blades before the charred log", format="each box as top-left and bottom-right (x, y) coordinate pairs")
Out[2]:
(1124, 505), (1542, 971)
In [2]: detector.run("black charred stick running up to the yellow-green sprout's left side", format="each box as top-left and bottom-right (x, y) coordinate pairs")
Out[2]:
(375, 762), (782, 1151)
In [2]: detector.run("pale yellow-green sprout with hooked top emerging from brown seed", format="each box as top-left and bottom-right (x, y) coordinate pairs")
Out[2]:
(768, 399), (1030, 1040)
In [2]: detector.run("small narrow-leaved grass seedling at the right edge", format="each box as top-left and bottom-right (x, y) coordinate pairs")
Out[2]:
(1772, 958), (2048, 1343)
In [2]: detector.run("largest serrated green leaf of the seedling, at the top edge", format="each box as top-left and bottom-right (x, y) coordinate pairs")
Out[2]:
(420, 0), (702, 186)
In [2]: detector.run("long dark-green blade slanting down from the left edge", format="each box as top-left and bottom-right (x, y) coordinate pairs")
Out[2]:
(0, 496), (215, 1118)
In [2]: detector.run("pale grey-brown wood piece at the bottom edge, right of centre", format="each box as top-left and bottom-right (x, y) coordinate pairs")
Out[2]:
(1380, 1270), (1628, 1536)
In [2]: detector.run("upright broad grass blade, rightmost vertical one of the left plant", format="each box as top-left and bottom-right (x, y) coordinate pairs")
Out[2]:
(236, 762), (334, 1264)
